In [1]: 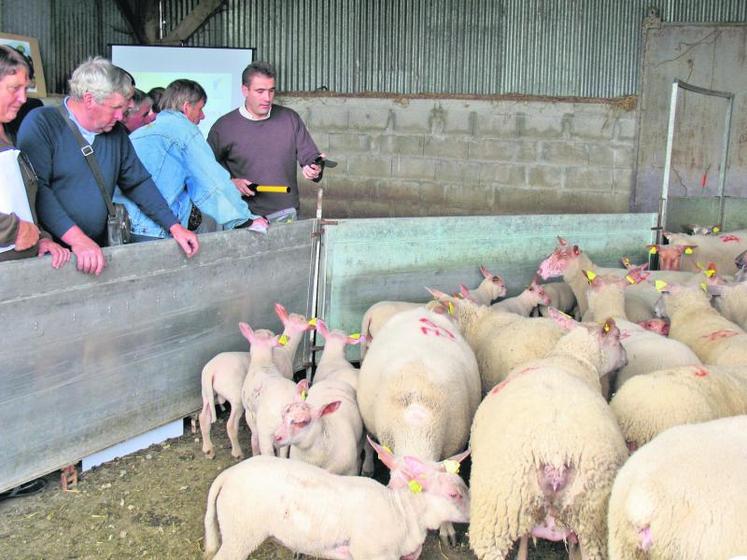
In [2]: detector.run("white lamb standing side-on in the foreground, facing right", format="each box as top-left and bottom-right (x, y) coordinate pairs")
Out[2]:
(205, 448), (469, 560)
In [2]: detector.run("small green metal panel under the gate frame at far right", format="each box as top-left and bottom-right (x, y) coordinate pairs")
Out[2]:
(666, 197), (747, 231)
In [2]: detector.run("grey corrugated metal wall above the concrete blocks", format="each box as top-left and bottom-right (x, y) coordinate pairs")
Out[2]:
(2, 0), (747, 97)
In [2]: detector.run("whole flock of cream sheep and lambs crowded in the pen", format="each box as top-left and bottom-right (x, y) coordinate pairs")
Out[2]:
(194, 225), (747, 560)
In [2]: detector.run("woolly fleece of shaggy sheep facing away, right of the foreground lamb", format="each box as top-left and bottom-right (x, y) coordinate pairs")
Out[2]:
(470, 329), (628, 558)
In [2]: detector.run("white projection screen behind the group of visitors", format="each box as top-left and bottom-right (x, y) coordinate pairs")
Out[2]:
(111, 45), (255, 136)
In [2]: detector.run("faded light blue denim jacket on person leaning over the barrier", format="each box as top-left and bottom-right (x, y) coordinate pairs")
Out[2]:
(114, 110), (257, 237)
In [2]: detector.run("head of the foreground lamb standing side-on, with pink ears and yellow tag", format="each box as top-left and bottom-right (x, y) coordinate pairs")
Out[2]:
(368, 437), (470, 529)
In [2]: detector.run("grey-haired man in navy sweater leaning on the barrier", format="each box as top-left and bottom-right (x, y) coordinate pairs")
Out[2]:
(18, 57), (199, 275)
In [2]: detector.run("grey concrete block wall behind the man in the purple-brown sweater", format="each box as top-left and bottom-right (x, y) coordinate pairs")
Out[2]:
(277, 96), (636, 218)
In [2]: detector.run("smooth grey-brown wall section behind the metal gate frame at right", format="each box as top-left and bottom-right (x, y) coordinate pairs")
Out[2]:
(633, 23), (747, 214)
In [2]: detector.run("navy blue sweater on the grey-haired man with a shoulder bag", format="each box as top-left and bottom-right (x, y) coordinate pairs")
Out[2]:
(18, 107), (177, 241)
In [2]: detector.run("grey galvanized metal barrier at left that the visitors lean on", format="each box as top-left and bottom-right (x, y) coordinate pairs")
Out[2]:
(0, 220), (314, 491)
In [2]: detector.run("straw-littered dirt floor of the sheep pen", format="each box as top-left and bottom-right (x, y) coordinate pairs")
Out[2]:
(0, 414), (567, 560)
